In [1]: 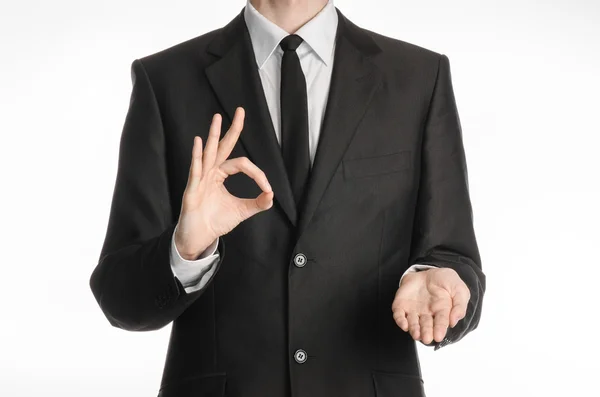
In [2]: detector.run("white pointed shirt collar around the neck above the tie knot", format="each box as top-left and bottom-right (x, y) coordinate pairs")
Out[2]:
(244, 0), (338, 69)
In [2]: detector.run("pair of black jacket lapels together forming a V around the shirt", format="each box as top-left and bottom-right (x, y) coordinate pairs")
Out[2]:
(206, 8), (381, 238)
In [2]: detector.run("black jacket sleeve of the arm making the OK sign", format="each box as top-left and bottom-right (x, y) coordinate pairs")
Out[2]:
(89, 59), (225, 331)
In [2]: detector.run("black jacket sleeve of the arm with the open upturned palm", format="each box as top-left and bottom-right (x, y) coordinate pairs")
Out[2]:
(409, 55), (485, 350)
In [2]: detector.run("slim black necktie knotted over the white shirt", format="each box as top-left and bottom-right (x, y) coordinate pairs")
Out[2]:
(279, 34), (310, 212)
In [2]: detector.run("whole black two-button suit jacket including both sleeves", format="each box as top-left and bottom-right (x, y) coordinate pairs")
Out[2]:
(90, 10), (485, 397)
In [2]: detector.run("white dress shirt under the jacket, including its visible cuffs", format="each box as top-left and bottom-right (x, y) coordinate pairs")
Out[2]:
(171, 0), (432, 293)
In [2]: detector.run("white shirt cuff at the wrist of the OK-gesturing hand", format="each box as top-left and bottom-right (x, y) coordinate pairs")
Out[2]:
(170, 226), (219, 293)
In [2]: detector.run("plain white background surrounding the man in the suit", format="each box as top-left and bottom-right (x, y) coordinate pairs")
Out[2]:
(0, 0), (600, 397)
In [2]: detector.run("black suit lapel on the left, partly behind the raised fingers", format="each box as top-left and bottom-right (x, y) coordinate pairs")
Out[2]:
(206, 11), (297, 226)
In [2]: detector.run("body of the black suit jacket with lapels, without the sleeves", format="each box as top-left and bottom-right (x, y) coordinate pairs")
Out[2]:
(142, 6), (439, 397)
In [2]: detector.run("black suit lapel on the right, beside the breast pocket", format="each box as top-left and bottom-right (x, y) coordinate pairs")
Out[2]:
(298, 9), (381, 238)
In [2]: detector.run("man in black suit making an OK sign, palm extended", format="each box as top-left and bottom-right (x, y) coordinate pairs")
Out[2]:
(90, 0), (485, 397)
